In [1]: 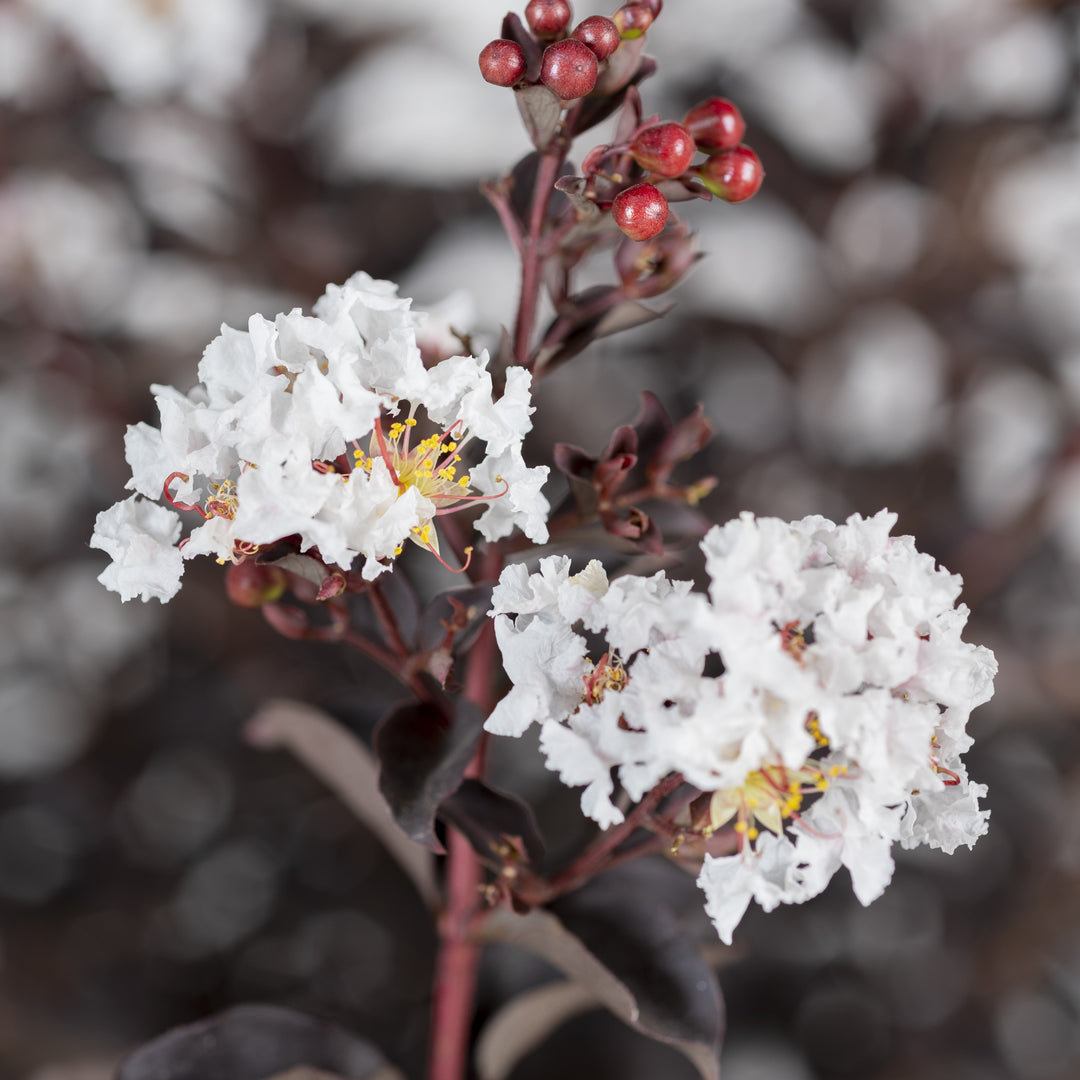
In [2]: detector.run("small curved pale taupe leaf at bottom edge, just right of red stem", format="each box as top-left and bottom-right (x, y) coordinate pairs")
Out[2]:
(475, 982), (603, 1080)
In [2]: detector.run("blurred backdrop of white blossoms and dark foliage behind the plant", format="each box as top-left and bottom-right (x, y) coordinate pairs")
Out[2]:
(0, 0), (1080, 1080)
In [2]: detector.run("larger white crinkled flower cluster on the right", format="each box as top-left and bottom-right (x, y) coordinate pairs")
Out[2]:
(487, 511), (997, 942)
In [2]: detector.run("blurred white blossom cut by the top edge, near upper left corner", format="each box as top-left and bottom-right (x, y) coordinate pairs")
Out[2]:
(27, 0), (270, 109)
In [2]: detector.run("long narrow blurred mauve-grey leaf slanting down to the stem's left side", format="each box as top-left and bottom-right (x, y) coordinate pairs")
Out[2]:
(244, 699), (440, 908)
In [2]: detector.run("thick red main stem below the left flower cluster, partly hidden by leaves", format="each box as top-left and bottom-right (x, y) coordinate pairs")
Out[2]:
(428, 546), (502, 1080)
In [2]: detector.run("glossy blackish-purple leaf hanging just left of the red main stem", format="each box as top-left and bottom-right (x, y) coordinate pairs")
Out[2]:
(374, 692), (484, 852)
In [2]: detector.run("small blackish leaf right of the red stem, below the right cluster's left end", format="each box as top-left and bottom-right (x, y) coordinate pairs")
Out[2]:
(438, 779), (543, 869)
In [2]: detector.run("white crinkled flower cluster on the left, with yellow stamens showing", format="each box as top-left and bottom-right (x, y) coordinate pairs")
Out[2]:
(91, 273), (549, 600)
